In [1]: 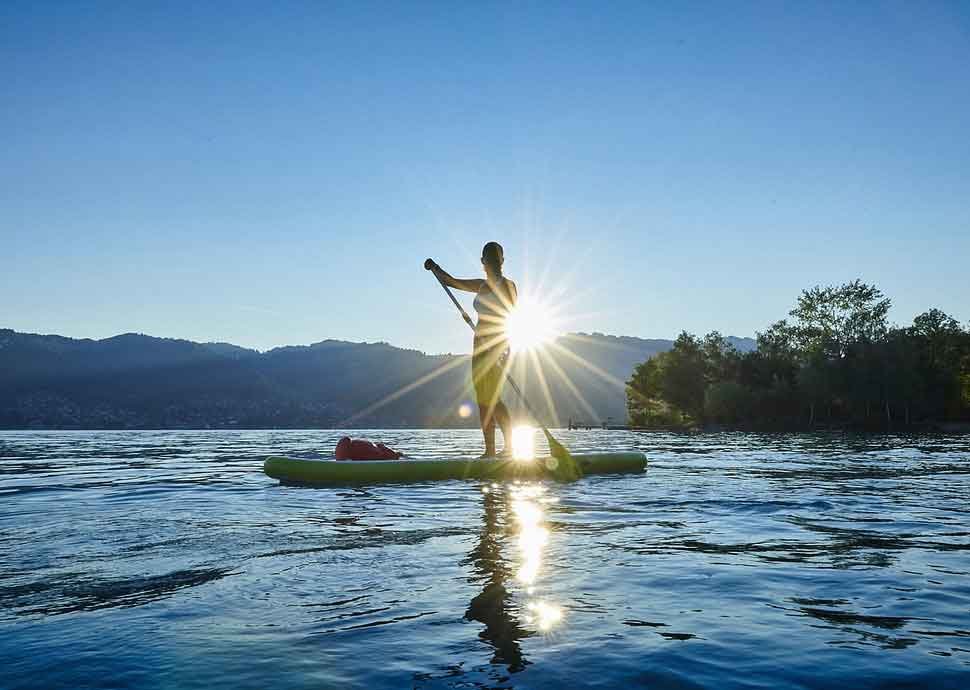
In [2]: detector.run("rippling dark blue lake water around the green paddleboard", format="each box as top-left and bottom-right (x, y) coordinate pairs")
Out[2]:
(0, 430), (970, 690)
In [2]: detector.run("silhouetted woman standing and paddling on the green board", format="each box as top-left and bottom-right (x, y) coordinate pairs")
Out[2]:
(428, 242), (518, 457)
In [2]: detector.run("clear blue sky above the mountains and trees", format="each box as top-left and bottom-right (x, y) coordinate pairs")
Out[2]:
(0, 1), (970, 353)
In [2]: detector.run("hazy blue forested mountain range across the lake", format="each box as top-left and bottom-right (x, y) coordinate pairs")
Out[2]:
(0, 329), (755, 429)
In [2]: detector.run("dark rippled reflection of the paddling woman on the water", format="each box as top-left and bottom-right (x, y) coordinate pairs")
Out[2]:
(465, 491), (532, 673)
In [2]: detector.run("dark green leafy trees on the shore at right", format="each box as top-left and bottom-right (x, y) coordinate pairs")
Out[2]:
(627, 280), (970, 429)
